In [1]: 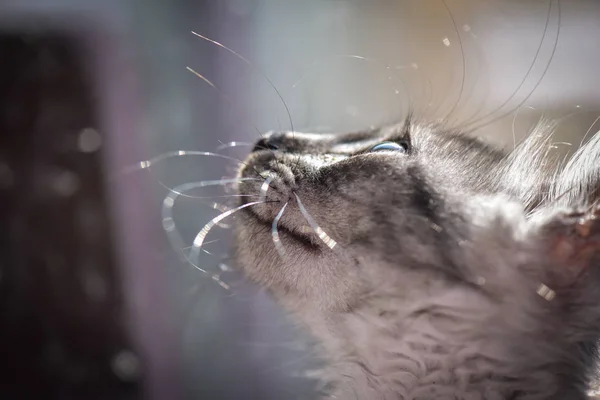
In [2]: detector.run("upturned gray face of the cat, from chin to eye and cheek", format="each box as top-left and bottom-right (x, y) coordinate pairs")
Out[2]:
(236, 122), (536, 311)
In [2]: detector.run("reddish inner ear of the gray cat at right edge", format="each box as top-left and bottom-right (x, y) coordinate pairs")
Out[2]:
(542, 203), (600, 288)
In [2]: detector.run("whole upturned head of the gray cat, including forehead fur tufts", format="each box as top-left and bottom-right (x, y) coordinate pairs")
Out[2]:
(236, 116), (598, 322)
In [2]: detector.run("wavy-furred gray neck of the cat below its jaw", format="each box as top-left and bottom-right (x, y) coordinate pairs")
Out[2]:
(292, 291), (586, 399)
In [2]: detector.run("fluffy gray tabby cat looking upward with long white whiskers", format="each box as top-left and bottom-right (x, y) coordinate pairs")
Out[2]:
(235, 119), (600, 400)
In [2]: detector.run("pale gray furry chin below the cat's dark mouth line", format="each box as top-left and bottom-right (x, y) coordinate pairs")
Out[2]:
(234, 215), (363, 311)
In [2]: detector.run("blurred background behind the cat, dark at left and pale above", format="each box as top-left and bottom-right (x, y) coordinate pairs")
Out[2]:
(0, 0), (600, 399)
